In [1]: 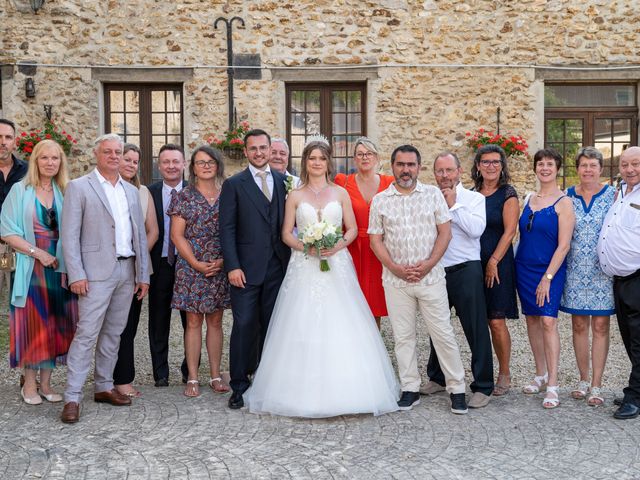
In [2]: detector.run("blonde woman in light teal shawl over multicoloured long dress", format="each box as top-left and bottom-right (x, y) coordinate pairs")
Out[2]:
(0, 140), (78, 405)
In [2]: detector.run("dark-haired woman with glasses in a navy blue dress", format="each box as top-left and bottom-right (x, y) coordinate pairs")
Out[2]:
(471, 145), (520, 396)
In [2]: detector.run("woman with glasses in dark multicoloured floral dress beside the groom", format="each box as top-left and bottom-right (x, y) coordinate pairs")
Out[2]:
(167, 146), (231, 397)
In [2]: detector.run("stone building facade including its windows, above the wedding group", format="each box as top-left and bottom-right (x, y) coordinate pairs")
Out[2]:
(0, 0), (640, 193)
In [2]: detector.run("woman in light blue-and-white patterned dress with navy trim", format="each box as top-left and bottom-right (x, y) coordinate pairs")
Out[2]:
(560, 147), (615, 406)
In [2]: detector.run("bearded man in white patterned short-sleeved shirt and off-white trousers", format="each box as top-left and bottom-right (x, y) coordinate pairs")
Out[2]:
(368, 145), (467, 414)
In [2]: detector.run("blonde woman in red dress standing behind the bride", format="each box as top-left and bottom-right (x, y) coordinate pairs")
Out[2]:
(334, 137), (393, 328)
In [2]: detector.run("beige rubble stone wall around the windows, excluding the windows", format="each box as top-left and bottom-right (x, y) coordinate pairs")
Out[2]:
(0, 0), (640, 193)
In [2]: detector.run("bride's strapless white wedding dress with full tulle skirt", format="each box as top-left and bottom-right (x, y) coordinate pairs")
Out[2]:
(244, 201), (399, 417)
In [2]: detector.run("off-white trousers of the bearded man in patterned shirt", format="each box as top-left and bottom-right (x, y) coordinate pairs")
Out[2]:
(384, 279), (465, 393)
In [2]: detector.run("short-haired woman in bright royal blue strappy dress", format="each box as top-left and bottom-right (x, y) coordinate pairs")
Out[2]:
(516, 148), (575, 408)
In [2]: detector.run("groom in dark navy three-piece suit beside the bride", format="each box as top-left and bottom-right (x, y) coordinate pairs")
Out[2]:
(220, 129), (291, 409)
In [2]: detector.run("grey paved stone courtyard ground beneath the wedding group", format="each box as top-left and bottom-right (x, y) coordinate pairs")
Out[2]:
(0, 296), (640, 480)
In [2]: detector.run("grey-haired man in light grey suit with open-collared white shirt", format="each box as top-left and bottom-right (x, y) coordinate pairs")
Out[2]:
(61, 134), (149, 423)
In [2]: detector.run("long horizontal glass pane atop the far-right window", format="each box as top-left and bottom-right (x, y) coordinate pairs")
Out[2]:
(544, 85), (636, 107)
